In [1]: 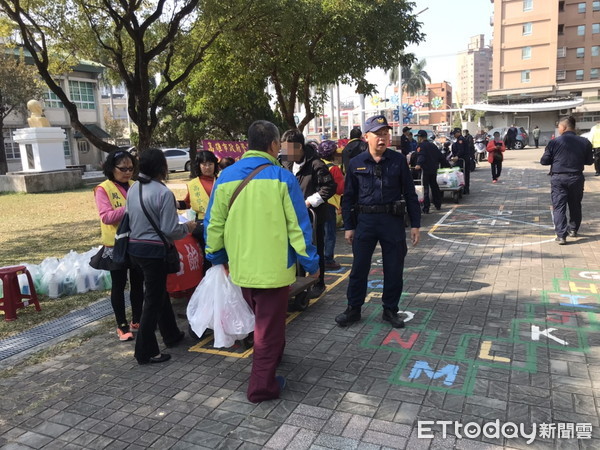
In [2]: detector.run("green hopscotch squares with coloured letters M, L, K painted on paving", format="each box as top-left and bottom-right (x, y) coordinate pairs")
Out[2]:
(361, 269), (600, 396)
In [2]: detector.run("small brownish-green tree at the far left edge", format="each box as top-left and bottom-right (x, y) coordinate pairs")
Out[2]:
(0, 45), (43, 175)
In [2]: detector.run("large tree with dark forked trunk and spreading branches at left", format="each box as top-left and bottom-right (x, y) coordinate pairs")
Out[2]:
(0, 0), (260, 151)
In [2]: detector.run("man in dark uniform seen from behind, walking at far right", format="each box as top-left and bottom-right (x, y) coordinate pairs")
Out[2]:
(540, 116), (594, 245)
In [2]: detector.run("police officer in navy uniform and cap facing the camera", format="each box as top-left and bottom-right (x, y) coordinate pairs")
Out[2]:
(335, 116), (421, 328)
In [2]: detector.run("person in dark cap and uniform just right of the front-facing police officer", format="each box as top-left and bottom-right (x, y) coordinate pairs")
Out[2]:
(415, 130), (448, 214)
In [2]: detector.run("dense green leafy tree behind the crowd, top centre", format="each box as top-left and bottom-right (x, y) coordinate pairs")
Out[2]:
(224, 0), (423, 130)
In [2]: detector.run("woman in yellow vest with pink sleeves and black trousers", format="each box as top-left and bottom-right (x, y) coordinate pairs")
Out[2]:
(94, 150), (144, 341)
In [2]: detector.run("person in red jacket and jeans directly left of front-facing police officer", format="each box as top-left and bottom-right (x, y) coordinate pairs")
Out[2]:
(317, 140), (344, 270)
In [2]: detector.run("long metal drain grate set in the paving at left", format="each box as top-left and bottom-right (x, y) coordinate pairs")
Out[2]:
(0, 298), (113, 361)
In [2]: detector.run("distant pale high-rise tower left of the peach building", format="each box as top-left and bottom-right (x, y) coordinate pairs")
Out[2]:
(454, 34), (492, 105)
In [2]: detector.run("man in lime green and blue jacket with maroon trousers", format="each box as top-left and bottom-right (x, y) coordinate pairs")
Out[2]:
(204, 120), (319, 403)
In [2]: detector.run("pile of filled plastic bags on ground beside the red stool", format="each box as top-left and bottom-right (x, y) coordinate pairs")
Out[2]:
(19, 247), (112, 298)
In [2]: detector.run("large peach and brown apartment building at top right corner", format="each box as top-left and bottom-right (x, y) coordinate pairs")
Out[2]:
(488, 0), (600, 137)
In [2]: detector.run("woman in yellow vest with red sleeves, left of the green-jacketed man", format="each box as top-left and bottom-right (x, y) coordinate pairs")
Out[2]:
(178, 150), (219, 272)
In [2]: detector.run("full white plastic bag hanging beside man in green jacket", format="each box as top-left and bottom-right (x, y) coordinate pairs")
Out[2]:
(187, 264), (254, 348)
